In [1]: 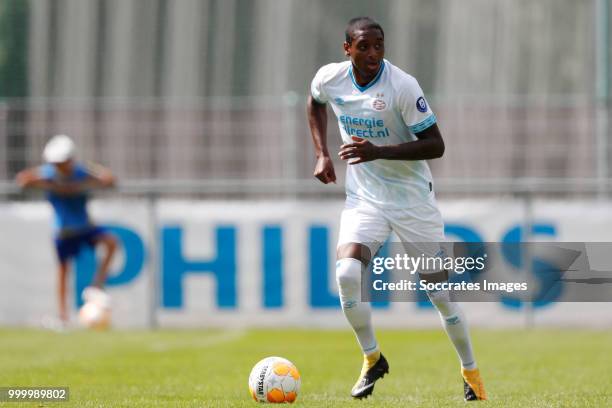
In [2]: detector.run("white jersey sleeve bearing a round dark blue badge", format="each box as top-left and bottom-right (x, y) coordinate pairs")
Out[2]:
(398, 77), (437, 133)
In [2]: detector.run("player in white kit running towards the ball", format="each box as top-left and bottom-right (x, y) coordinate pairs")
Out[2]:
(307, 17), (487, 400)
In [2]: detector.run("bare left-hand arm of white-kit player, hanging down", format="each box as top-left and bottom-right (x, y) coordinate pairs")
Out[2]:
(306, 95), (336, 184)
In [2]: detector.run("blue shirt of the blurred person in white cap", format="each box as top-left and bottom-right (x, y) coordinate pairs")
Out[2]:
(40, 163), (92, 235)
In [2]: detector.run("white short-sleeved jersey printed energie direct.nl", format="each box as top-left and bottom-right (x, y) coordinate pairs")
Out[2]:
(311, 60), (436, 209)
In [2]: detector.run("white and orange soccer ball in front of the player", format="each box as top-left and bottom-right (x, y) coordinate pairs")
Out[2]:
(249, 357), (301, 403)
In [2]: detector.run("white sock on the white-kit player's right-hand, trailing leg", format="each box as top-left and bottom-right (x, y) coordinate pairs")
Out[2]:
(427, 291), (476, 370)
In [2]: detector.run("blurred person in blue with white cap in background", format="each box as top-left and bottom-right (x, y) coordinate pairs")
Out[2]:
(16, 135), (117, 327)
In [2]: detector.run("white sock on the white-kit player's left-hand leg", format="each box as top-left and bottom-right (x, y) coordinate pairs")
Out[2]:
(336, 258), (378, 354)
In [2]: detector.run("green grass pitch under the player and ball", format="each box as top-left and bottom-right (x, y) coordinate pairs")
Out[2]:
(0, 329), (612, 407)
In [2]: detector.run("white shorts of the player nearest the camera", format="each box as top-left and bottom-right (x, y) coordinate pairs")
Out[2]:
(338, 200), (444, 256)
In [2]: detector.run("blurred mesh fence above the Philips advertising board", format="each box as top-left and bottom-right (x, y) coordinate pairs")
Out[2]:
(0, 94), (611, 198)
